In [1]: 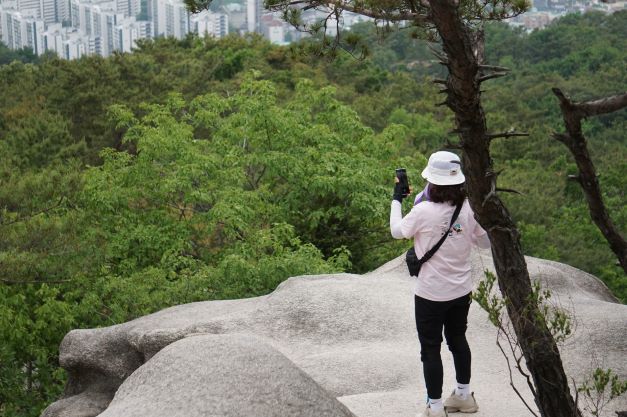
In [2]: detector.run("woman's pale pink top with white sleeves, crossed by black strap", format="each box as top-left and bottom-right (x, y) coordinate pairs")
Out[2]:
(390, 200), (490, 301)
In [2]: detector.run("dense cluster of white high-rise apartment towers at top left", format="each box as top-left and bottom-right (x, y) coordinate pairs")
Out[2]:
(0, 0), (229, 59)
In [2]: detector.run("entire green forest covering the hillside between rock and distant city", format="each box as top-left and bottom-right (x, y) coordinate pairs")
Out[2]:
(0, 12), (627, 417)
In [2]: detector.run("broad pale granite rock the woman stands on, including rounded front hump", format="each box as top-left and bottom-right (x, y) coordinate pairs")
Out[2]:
(43, 252), (627, 417)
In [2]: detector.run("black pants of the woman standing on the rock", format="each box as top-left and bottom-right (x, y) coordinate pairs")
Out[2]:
(415, 294), (471, 398)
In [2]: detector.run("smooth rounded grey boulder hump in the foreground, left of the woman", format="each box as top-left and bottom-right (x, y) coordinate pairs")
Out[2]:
(100, 335), (353, 417)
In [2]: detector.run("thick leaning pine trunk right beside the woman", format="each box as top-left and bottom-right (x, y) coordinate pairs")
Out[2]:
(429, 0), (581, 417)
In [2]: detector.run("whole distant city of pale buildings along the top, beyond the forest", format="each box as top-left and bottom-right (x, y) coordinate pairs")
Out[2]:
(0, 0), (627, 59)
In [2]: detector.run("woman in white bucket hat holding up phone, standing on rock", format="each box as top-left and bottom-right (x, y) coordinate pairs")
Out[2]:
(390, 151), (490, 417)
